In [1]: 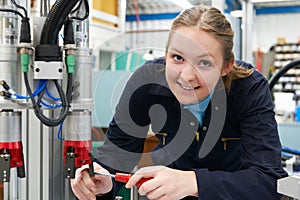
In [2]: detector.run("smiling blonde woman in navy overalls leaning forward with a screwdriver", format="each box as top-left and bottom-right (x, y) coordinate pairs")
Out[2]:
(71, 6), (287, 200)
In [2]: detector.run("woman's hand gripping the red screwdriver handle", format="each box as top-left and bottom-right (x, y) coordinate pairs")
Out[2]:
(126, 166), (198, 200)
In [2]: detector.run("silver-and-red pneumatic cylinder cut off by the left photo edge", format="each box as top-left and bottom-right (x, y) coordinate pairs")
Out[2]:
(0, 110), (25, 182)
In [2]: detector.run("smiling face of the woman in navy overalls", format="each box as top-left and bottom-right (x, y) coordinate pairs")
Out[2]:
(166, 26), (229, 104)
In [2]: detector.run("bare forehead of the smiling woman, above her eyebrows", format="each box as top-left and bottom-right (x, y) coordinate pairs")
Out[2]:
(168, 27), (222, 58)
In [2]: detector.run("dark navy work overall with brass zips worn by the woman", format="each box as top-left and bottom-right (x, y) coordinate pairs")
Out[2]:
(95, 58), (287, 200)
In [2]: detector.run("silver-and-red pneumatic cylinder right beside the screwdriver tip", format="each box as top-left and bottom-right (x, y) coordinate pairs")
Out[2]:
(63, 111), (93, 179)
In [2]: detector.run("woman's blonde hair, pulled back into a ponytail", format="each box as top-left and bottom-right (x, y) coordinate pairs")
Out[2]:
(166, 5), (253, 90)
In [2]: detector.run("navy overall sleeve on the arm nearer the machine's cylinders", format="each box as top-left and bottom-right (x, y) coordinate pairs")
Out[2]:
(95, 63), (155, 199)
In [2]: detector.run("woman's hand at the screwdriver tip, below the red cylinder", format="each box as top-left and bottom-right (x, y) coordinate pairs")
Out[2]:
(71, 163), (112, 200)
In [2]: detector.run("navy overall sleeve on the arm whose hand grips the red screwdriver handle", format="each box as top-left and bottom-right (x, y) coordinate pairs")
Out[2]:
(195, 72), (287, 200)
